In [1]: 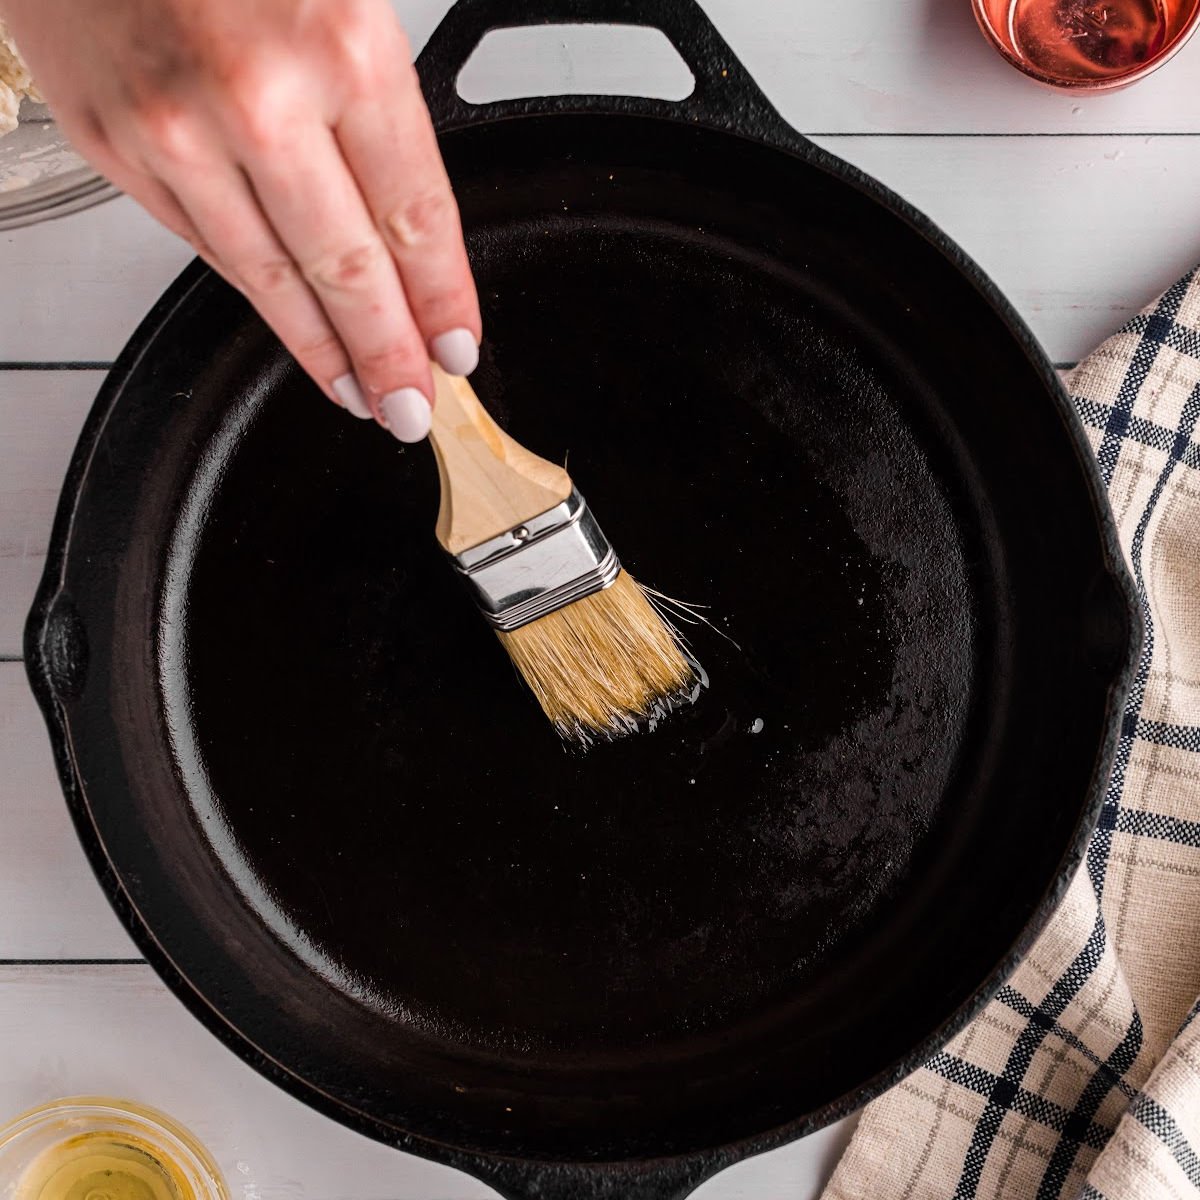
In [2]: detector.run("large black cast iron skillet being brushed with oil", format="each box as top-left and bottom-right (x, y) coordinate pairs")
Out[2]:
(28, 0), (1138, 1198)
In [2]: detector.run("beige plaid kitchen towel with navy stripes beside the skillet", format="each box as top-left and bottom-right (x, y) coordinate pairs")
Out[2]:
(824, 268), (1200, 1200)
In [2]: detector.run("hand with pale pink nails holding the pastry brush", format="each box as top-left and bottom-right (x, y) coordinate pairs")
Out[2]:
(0, 0), (481, 442)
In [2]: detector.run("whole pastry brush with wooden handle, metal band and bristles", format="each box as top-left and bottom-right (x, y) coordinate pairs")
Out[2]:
(430, 367), (697, 744)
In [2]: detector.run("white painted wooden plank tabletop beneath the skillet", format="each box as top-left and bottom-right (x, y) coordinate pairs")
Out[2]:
(0, 0), (1200, 1200)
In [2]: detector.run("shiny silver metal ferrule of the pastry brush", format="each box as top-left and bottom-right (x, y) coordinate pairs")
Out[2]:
(451, 490), (620, 632)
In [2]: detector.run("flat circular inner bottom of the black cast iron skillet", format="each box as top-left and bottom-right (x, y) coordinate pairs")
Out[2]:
(173, 220), (980, 1063)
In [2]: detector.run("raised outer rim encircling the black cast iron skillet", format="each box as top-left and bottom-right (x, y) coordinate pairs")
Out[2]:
(24, 105), (1142, 1195)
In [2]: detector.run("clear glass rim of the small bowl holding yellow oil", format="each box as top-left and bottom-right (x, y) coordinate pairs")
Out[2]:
(0, 1096), (229, 1200)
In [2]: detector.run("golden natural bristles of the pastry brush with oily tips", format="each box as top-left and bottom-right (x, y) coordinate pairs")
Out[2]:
(499, 571), (696, 743)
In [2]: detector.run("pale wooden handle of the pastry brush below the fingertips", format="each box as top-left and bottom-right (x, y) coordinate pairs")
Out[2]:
(430, 366), (571, 554)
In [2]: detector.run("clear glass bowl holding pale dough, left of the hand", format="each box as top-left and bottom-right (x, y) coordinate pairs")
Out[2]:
(0, 100), (120, 229)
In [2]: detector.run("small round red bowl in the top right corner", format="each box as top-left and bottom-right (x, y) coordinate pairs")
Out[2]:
(972, 0), (1200, 91)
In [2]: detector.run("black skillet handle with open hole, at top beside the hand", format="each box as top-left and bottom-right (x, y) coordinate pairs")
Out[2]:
(416, 0), (809, 149)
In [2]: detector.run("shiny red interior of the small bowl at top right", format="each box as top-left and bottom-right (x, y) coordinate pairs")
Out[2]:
(1008, 0), (1166, 80)
